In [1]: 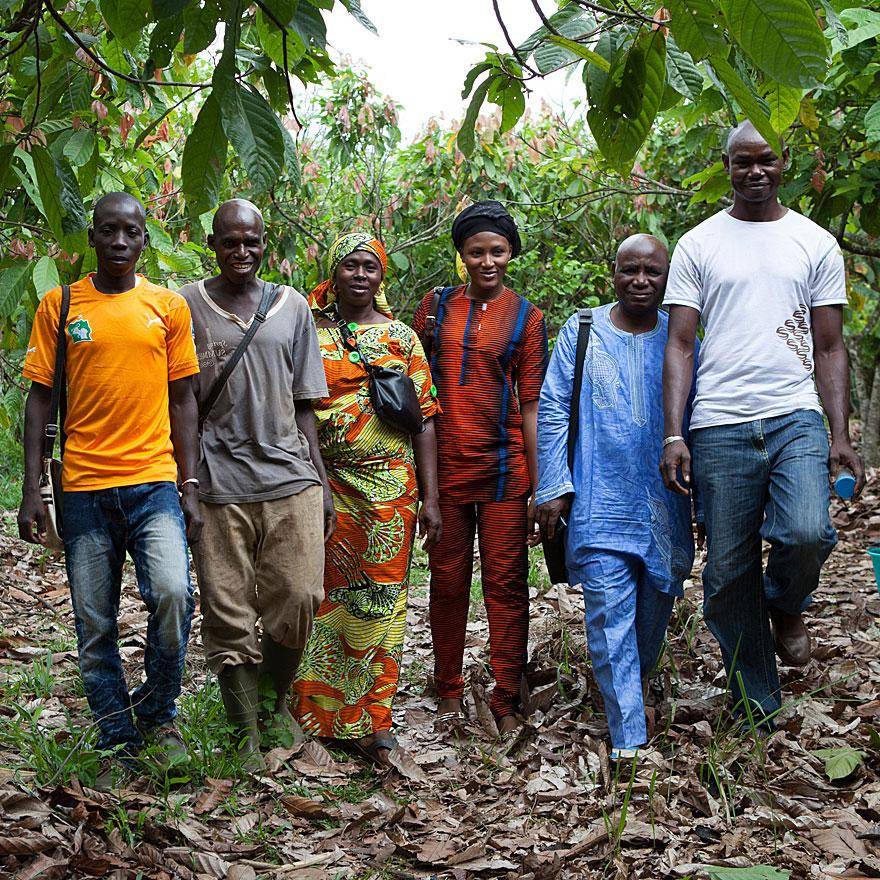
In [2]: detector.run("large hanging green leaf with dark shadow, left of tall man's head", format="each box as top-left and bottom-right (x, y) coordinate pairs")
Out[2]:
(587, 29), (666, 174)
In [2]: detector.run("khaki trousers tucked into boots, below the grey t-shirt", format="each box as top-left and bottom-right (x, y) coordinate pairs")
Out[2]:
(193, 486), (324, 673)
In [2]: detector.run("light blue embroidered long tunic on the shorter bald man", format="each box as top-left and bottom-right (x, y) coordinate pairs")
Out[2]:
(535, 304), (694, 596)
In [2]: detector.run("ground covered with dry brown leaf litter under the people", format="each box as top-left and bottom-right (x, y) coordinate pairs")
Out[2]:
(0, 477), (880, 880)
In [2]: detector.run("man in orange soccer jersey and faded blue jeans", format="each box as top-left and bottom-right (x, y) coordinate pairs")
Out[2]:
(18, 193), (201, 764)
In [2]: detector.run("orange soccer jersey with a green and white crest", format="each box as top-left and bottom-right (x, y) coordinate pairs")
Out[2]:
(23, 275), (199, 491)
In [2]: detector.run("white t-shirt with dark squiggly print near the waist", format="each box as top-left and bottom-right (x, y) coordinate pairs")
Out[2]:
(664, 209), (847, 429)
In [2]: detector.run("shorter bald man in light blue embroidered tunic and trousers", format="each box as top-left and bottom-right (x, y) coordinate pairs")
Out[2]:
(535, 235), (694, 759)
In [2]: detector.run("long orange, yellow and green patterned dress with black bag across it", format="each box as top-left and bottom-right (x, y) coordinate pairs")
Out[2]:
(294, 321), (439, 739)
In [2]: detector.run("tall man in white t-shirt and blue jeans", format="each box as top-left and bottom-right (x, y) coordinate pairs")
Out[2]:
(660, 122), (864, 727)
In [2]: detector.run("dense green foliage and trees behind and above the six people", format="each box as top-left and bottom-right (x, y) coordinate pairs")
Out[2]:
(0, 0), (880, 464)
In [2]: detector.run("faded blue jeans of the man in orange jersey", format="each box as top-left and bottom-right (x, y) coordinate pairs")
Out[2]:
(64, 482), (195, 750)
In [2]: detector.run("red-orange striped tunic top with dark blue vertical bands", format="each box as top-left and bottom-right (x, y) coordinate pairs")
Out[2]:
(413, 285), (547, 502)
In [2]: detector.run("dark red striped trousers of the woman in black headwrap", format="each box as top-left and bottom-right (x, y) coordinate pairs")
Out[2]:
(429, 496), (529, 718)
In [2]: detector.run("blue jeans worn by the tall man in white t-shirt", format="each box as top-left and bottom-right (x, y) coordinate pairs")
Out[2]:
(690, 410), (837, 715)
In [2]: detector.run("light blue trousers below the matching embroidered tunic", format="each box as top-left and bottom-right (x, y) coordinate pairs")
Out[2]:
(572, 550), (675, 749)
